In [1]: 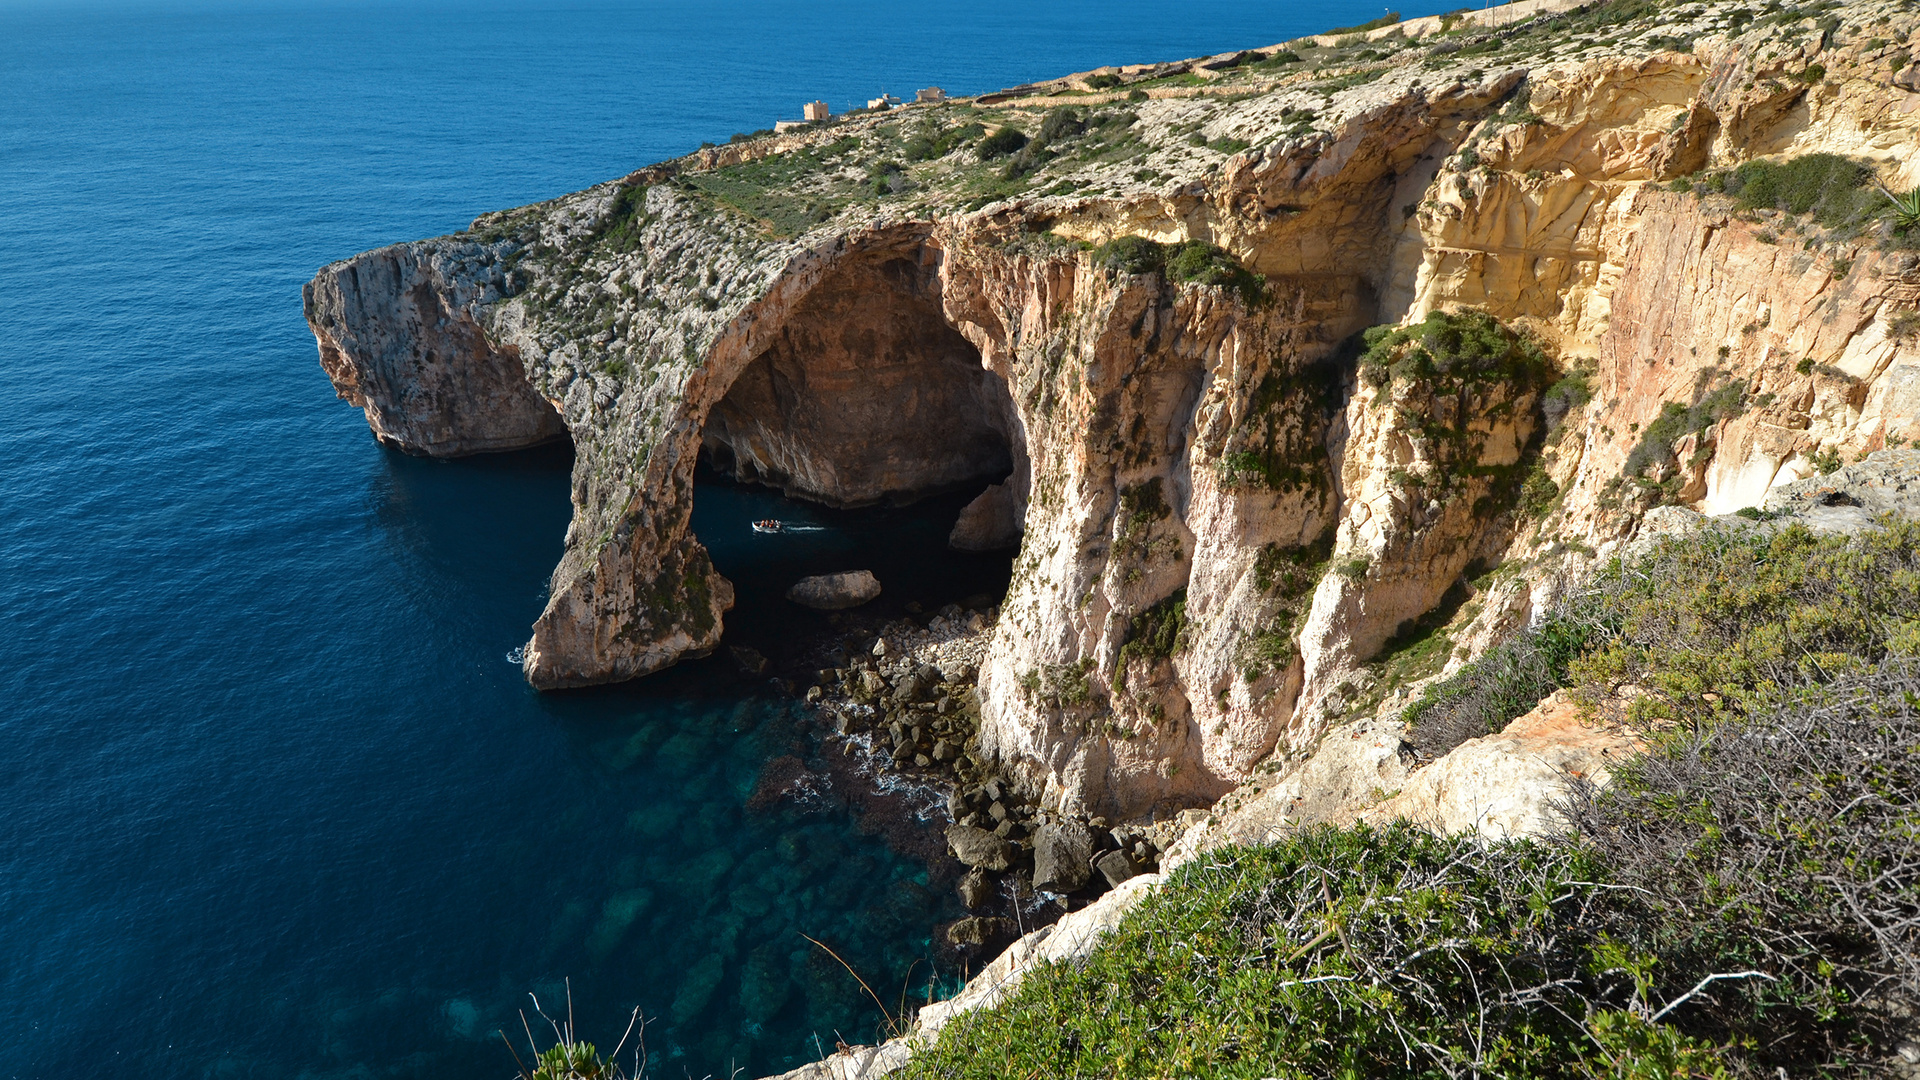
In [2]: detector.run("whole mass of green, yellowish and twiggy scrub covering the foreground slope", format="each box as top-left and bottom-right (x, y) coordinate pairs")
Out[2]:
(908, 521), (1920, 1078)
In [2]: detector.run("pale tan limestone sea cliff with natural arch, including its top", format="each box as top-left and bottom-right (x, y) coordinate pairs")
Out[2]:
(307, 2), (1920, 817)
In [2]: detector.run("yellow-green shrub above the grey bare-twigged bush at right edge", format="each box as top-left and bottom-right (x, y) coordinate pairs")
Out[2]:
(1404, 519), (1920, 757)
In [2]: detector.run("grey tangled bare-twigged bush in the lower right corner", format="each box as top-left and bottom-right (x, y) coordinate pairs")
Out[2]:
(1571, 663), (1920, 1074)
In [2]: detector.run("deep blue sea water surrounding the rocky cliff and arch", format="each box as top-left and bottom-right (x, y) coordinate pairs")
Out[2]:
(0, 0), (1443, 1080)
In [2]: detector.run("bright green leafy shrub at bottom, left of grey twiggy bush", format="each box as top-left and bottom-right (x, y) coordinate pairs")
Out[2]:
(902, 824), (1724, 1080)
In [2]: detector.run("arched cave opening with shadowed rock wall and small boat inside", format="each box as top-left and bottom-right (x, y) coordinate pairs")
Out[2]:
(693, 248), (1029, 665)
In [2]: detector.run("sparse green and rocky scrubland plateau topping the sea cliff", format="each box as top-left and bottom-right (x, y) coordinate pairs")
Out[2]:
(487, 0), (1908, 236)
